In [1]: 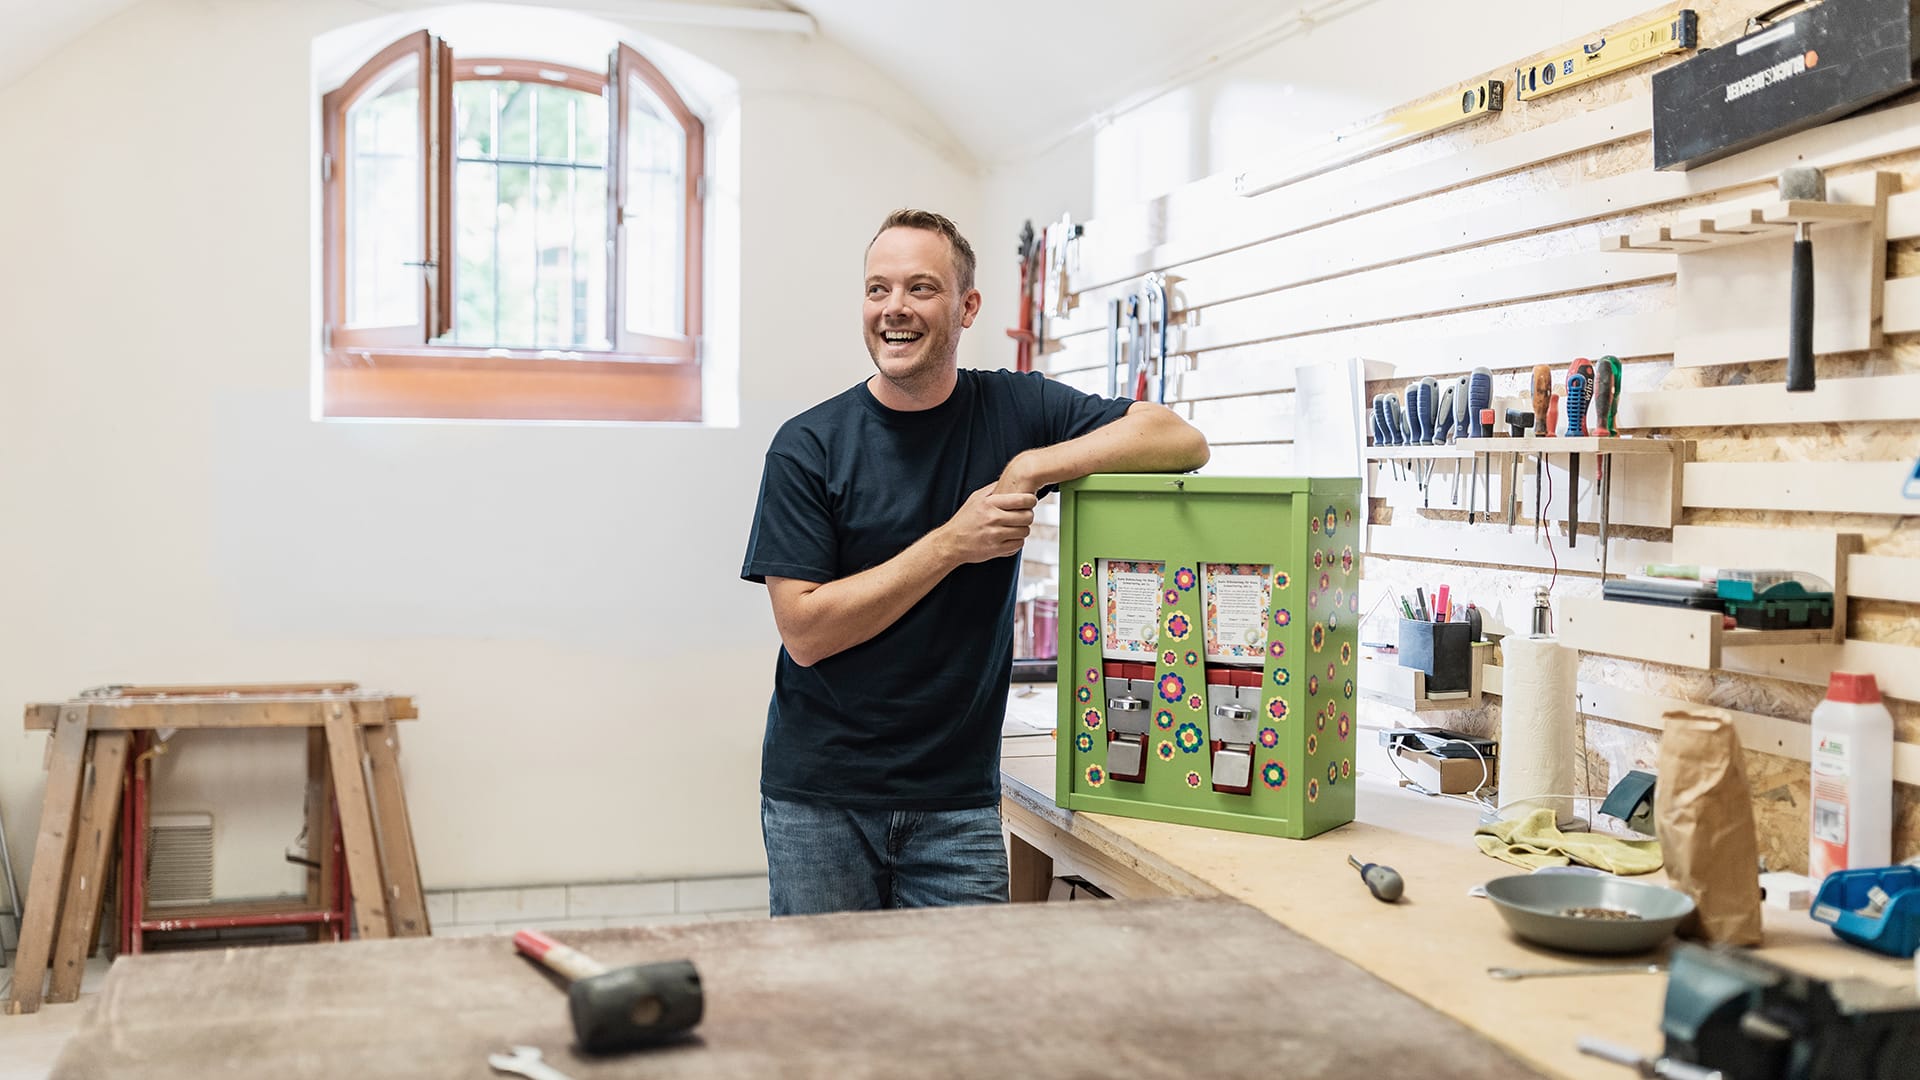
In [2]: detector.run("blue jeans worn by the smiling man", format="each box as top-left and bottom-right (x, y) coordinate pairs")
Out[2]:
(760, 796), (1006, 915)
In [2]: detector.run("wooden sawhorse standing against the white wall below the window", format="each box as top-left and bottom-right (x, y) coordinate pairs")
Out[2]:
(6, 682), (430, 1013)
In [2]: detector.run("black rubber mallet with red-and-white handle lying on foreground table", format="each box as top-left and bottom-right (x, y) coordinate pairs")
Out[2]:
(513, 930), (707, 1053)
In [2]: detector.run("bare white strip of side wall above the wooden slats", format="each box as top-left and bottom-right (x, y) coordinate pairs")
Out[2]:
(981, 0), (1651, 345)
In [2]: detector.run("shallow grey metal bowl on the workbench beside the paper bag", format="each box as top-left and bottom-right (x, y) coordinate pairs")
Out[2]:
(1486, 874), (1693, 953)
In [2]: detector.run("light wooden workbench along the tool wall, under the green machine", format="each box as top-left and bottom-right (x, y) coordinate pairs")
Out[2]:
(1000, 722), (1914, 1080)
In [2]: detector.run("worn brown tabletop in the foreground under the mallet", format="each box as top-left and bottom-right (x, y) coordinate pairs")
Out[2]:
(52, 899), (1534, 1080)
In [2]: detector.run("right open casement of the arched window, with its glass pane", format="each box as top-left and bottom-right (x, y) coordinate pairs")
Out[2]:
(607, 44), (707, 359)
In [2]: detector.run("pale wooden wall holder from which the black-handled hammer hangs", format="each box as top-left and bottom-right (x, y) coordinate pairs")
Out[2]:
(1601, 173), (1897, 367)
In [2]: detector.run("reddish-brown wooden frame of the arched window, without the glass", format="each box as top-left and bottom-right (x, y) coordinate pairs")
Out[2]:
(321, 31), (707, 423)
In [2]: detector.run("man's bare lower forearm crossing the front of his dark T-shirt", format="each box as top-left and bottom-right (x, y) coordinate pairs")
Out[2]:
(774, 528), (960, 667)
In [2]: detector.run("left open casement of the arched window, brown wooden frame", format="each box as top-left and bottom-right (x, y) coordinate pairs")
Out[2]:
(323, 31), (453, 350)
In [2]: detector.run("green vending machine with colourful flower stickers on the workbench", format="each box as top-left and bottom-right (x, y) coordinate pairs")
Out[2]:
(1054, 473), (1365, 838)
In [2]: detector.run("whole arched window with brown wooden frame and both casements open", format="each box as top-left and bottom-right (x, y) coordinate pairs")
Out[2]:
(321, 31), (705, 421)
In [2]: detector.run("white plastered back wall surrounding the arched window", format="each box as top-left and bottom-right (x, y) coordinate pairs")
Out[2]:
(0, 0), (996, 892)
